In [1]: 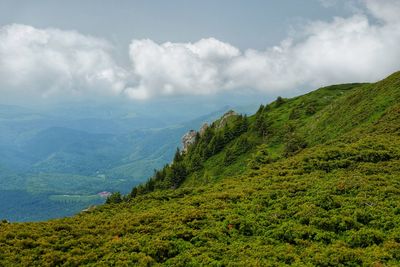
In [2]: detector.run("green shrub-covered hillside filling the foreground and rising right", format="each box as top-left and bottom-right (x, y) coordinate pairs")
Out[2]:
(0, 73), (400, 266)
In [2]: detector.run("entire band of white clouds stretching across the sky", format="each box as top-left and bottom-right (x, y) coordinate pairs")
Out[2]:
(0, 0), (400, 99)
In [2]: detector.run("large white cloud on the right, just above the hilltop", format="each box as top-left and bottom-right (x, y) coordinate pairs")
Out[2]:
(229, 12), (400, 91)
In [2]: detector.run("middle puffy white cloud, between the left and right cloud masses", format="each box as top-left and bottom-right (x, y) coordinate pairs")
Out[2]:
(127, 38), (240, 98)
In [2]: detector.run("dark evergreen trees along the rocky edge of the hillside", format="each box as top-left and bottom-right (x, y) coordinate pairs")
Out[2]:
(107, 97), (307, 203)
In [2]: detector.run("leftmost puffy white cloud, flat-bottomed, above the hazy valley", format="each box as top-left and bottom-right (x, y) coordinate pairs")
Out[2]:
(0, 24), (126, 100)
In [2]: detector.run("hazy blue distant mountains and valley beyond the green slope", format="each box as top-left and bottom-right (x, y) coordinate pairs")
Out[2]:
(0, 105), (252, 221)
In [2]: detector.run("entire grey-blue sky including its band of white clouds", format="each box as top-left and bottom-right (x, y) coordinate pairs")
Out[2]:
(0, 0), (400, 102)
